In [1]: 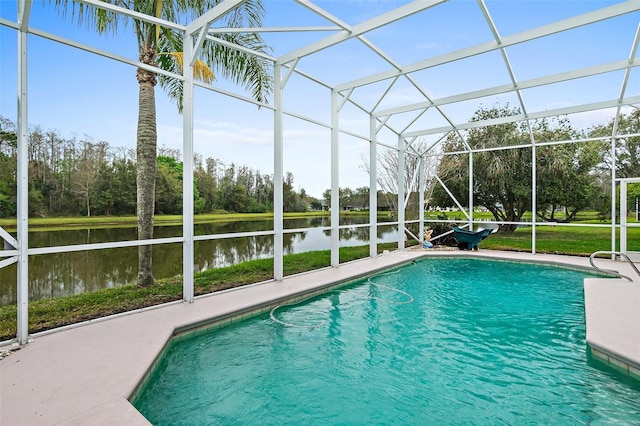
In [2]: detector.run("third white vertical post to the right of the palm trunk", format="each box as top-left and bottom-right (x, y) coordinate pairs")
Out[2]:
(331, 90), (340, 267)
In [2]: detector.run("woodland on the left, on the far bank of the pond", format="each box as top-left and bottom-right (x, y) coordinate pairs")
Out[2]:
(0, 116), (313, 217)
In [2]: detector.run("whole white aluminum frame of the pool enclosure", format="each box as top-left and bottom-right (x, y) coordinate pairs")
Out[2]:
(0, 0), (640, 345)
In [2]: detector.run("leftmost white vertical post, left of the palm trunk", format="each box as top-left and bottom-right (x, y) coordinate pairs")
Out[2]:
(16, 2), (29, 345)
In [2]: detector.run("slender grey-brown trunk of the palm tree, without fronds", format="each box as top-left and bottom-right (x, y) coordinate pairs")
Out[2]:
(136, 49), (158, 287)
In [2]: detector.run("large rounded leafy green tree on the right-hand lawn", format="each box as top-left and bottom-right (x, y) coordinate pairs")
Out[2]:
(434, 106), (600, 232)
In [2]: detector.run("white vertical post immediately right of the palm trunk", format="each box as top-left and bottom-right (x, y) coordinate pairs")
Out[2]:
(182, 34), (195, 303)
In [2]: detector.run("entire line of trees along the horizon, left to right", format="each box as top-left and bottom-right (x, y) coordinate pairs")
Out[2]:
(0, 106), (640, 223)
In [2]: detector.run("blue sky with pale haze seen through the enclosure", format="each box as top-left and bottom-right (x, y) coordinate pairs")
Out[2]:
(0, 0), (640, 197)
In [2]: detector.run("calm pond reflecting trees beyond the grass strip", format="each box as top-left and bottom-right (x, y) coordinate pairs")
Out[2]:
(0, 217), (398, 305)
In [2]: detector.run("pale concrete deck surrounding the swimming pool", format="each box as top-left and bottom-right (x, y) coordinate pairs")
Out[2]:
(0, 250), (640, 426)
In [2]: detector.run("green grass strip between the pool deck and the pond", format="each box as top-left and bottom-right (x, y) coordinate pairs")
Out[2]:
(0, 243), (396, 340)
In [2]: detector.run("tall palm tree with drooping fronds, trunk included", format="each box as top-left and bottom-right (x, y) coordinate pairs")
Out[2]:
(54, 0), (272, 286)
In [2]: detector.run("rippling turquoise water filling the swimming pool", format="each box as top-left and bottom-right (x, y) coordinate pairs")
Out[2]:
(134, 258), (640, 425)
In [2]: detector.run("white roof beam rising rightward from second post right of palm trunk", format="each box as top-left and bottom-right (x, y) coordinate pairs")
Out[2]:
(276, 0), (446, 65)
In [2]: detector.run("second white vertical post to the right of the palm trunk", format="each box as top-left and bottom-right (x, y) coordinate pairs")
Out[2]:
(273, 65), (284, 281)
